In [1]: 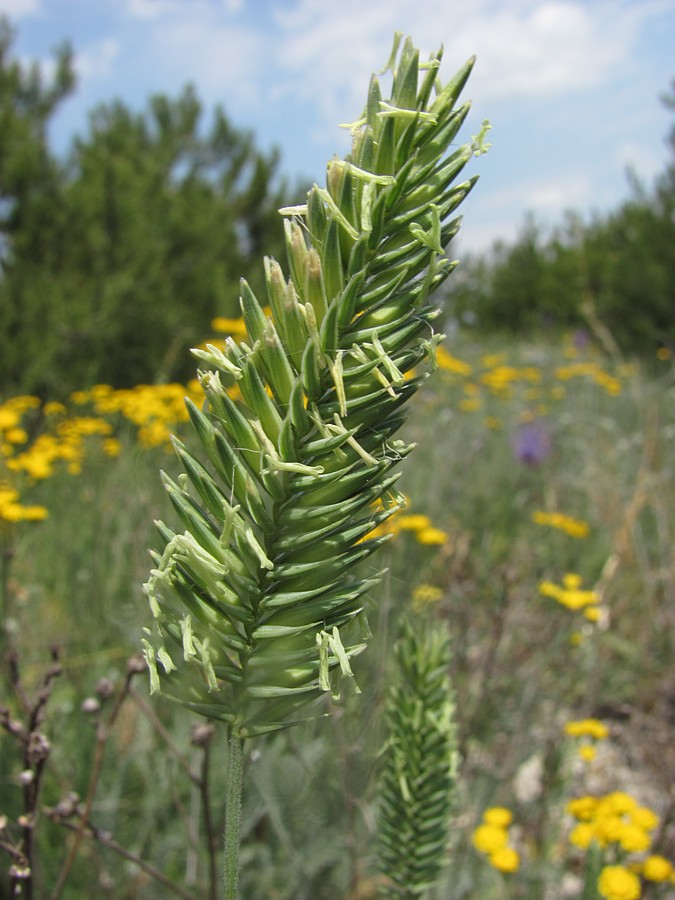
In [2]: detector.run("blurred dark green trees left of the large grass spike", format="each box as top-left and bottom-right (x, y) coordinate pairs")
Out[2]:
(0, 23), (294, 396)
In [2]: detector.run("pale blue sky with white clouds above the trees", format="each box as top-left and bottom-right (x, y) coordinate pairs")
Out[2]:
(0, 0), (675, 250)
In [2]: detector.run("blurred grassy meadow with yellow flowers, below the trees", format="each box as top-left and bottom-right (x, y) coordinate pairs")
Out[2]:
(0, 335), (675, 900)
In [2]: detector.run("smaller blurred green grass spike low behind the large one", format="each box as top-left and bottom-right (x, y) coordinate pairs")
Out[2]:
(377, 621), (458, 898)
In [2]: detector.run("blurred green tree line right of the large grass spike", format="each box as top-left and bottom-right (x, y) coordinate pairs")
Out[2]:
(448, 80), (675, 353)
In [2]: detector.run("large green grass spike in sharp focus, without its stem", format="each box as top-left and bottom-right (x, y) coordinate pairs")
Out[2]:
(145, 35), (483, 738)
